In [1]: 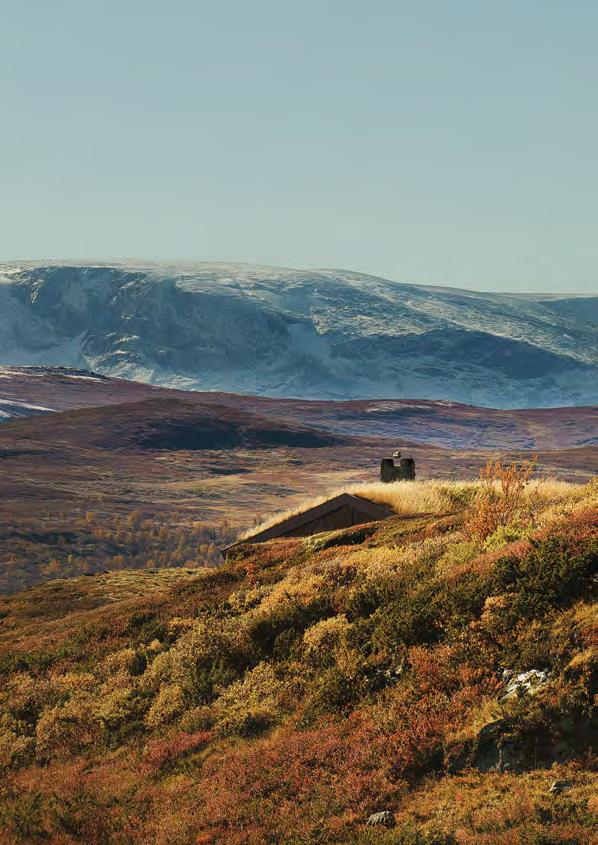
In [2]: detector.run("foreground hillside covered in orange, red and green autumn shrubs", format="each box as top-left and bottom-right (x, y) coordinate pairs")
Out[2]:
(0, 477), (598, 845)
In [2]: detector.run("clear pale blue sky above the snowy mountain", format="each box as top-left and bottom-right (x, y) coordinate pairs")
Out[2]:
(0, 0), (598, 292)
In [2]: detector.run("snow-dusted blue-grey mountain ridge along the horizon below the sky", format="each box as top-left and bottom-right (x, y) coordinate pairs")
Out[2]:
(0, 262), (598, 411)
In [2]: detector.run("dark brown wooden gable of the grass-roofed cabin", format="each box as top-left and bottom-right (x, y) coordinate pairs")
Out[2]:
(222, 493), (396, 557)
